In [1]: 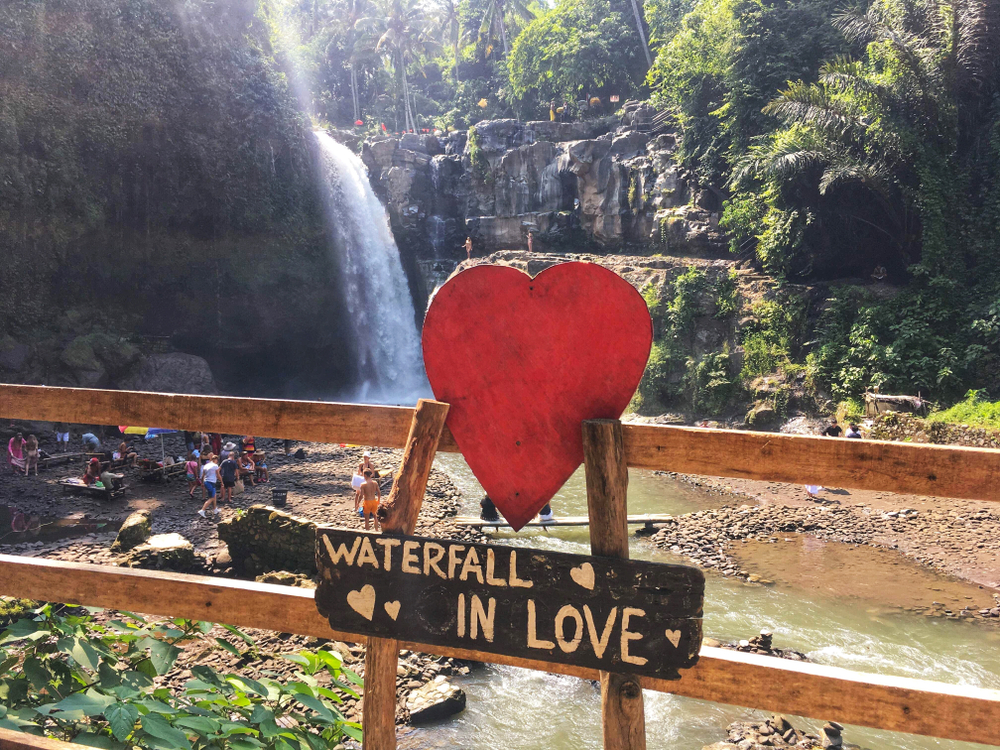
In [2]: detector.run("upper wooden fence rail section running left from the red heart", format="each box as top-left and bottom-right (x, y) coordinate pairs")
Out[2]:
(0, 385), (457, 451)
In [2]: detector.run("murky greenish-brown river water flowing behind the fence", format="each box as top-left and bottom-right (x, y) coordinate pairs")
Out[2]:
(400, 455), (1000, 750)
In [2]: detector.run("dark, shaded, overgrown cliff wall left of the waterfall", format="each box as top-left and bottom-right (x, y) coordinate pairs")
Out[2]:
(0, 0), (352, 396)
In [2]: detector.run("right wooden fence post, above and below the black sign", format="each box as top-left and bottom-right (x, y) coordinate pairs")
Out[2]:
(583, 419), (646, 750)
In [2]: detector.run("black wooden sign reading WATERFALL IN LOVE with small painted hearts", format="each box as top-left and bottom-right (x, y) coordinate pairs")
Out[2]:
(316, 527), (705, 679)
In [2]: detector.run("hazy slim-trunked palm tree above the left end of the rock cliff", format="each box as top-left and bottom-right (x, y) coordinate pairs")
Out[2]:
(358, 0), (435, 130)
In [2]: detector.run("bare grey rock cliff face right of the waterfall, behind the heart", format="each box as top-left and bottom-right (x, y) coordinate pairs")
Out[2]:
(362, 111), (723, 264)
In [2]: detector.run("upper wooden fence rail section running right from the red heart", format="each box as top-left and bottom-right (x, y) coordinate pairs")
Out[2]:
(623, 425), (1000, 501)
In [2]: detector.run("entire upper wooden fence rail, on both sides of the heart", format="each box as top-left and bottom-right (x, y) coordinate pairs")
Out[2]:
(0, 385), (1000, 502)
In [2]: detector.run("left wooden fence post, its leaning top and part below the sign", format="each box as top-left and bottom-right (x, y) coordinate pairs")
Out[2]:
(361, 399), (448, 750)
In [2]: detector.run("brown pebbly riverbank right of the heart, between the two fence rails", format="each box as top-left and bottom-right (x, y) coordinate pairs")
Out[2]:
(652, 472), (1000, 624)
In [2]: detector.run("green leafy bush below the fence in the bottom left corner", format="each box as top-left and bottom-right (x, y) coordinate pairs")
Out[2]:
(0, 604), (361, 750)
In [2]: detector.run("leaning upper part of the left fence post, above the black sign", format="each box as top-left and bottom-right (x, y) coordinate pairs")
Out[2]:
(378, 399), (448, 534)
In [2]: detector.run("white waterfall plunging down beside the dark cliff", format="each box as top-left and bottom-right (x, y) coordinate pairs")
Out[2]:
(315, 131), (430, 403)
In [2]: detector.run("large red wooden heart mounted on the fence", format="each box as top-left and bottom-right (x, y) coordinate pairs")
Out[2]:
(423, 262), (653, 530)
